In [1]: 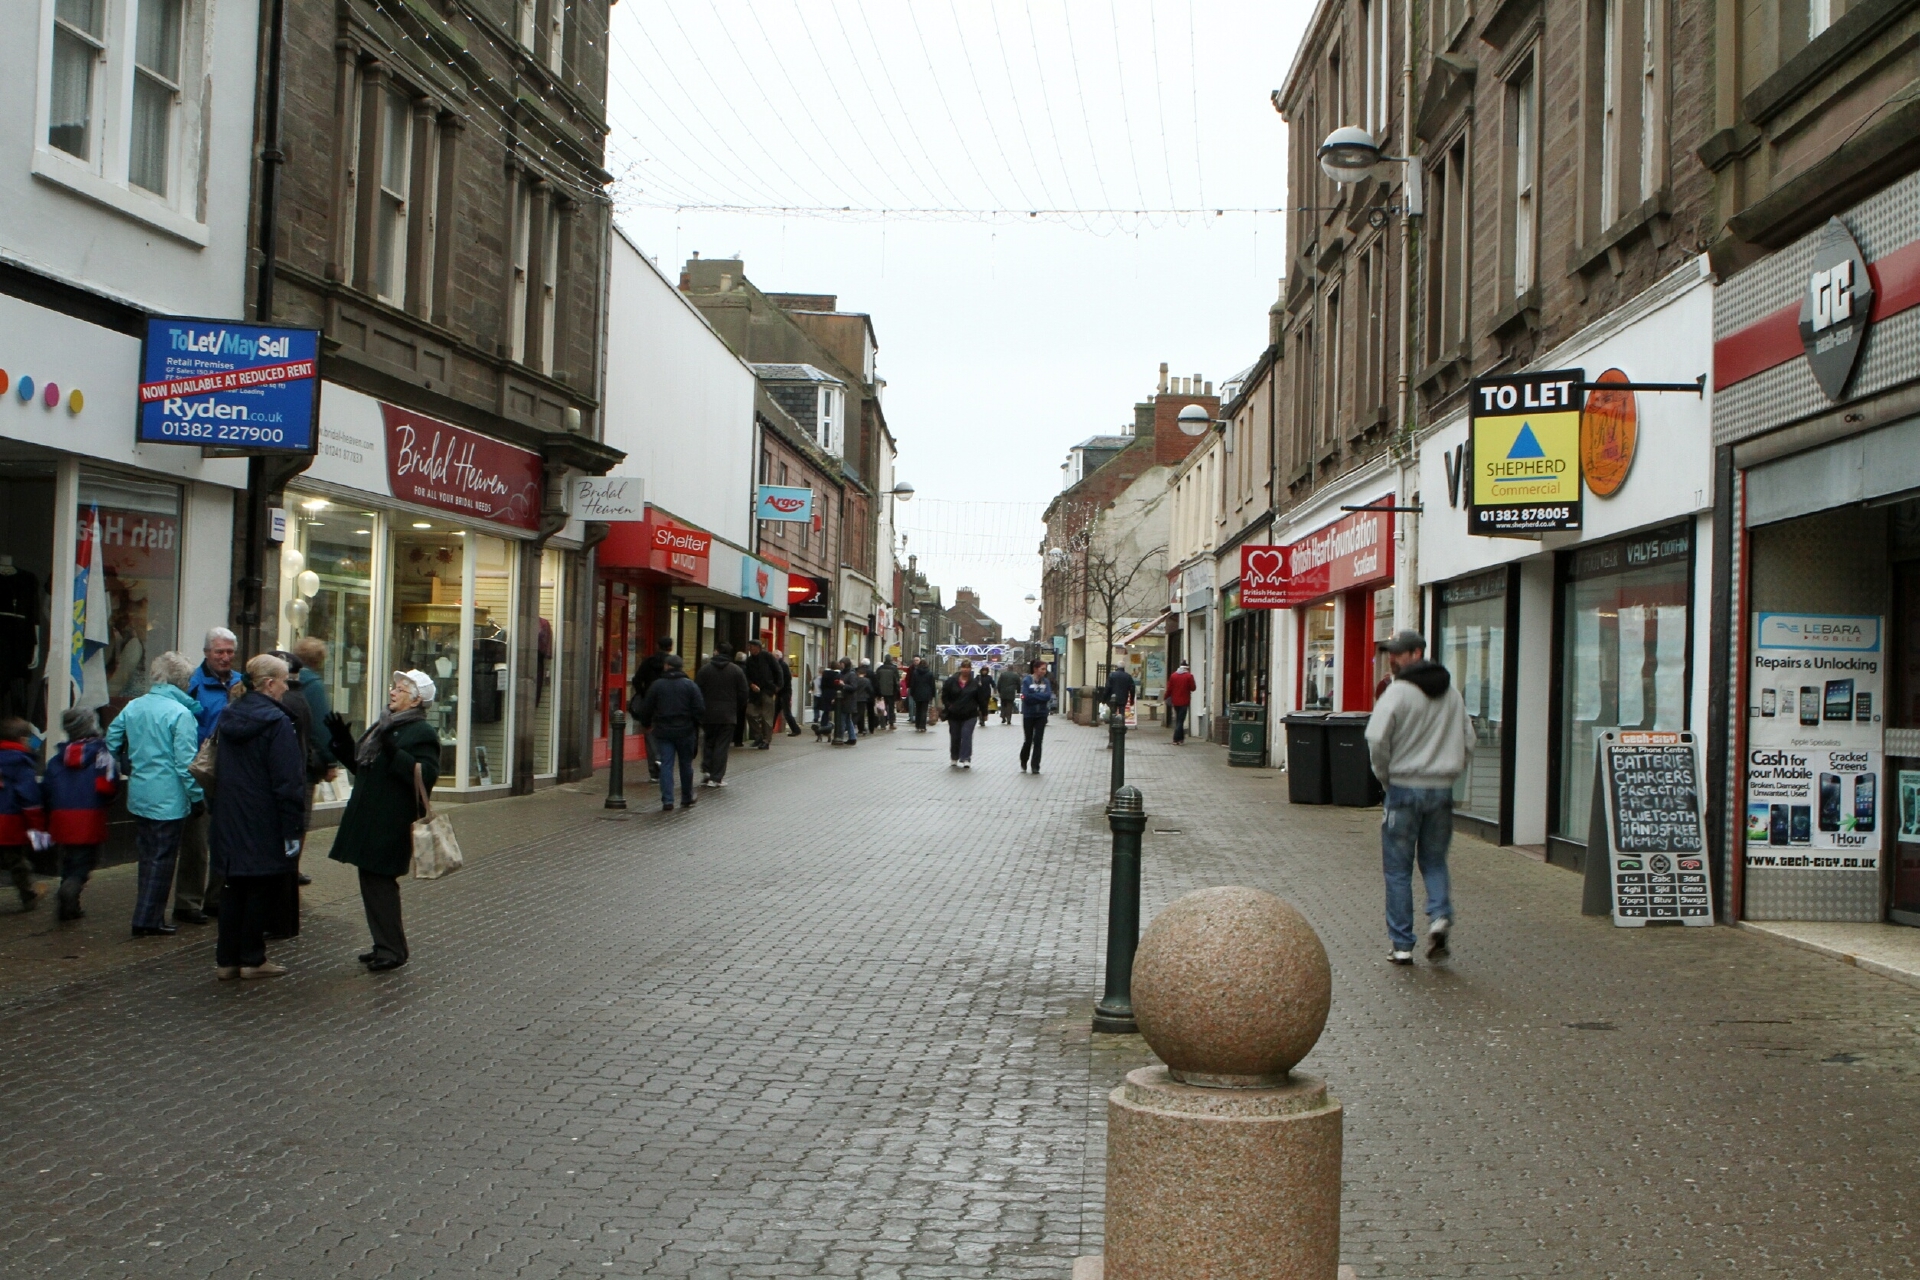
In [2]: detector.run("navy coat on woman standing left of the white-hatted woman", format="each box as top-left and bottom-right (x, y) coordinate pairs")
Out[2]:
(207, 693), (307, 875)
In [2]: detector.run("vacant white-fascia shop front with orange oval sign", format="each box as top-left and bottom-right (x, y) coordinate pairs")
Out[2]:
(1417, 265), (1713, 869)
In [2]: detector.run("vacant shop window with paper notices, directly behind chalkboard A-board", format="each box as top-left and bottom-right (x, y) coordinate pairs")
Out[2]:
(1555, 524), (1693, 841)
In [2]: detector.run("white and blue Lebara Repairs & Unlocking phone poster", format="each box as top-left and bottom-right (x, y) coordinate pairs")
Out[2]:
(1747, 614), (1881, 871)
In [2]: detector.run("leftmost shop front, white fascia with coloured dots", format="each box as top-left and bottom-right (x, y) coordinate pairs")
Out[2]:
(0, 297), (246, 752)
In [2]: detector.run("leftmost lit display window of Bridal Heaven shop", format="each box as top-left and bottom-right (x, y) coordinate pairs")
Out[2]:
(280, 495), (386, 737)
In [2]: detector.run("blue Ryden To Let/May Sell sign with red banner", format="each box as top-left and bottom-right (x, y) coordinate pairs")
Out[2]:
(136, 317), (321, 453)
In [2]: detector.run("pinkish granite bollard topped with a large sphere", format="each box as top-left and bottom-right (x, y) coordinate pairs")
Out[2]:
(1102, 887), (1340, 1280)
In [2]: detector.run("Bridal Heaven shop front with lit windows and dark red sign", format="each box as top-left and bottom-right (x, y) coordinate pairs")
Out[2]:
(295, 384), (580, 804)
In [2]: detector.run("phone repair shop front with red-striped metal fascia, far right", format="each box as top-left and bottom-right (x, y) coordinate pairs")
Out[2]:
(1713, 177), (1920, 925)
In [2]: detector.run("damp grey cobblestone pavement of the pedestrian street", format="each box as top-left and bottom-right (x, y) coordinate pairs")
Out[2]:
(0, 725), (1920, 1280)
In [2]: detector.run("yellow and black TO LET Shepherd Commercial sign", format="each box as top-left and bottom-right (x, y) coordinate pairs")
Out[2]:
(1467, 368), (1586, 537)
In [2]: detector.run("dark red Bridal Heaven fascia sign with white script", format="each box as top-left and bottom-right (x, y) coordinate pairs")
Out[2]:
(380, 405), (541, 532)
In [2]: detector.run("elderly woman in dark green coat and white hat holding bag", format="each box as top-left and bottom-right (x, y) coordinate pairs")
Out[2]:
(326, 672), (440, 973)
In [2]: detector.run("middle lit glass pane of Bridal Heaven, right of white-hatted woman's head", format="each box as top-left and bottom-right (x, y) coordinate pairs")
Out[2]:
(387, 516), (467, 787)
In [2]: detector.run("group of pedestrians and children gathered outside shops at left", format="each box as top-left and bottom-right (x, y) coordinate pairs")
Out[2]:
(0, 628), (440, 979)
